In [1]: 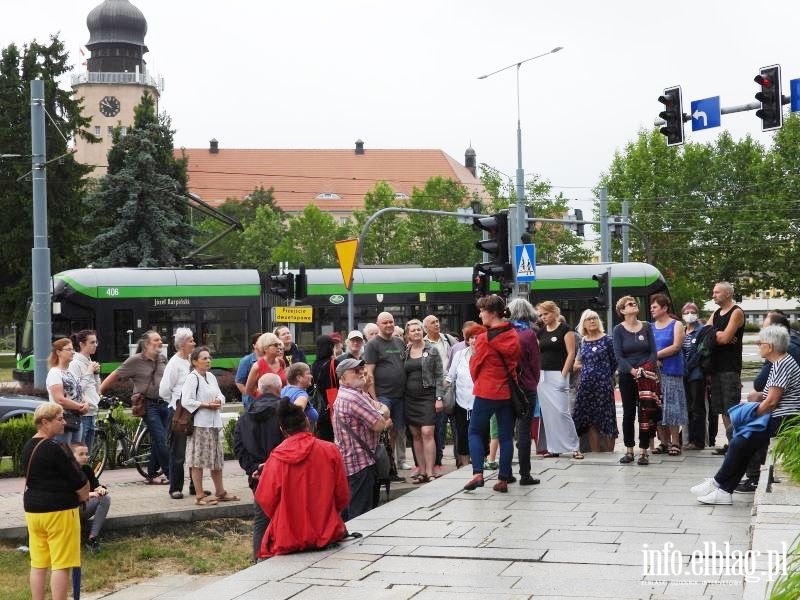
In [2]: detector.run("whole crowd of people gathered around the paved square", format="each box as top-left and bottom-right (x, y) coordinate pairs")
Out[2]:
(23, 282), (800, 590)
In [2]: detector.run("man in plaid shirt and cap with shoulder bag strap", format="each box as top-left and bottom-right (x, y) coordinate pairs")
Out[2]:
(333, 358), (392, 521)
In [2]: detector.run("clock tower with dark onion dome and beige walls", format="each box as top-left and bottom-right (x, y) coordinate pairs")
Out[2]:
(72, 0), (163, 177)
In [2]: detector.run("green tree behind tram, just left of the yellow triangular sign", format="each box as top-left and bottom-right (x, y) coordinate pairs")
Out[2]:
(273, 204), (351, 269)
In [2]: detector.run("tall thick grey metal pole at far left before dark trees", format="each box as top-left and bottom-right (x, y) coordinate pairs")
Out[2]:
(31, 79), (52, 388)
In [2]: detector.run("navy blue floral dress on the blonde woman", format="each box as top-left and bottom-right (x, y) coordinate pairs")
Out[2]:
(572, 335), (619, 438)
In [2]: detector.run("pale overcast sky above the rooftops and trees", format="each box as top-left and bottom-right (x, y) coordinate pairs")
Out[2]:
(0, 0), (800, 210)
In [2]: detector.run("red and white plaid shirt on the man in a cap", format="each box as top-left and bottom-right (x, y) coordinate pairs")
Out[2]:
(333, 385), (381, 477)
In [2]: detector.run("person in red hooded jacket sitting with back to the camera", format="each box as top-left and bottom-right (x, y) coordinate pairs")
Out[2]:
(255, 399), (350, 560)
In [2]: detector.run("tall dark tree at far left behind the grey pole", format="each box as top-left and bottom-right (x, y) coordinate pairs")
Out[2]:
(0, 36), (92, 323)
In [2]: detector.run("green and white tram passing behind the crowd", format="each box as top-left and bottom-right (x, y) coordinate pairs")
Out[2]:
(14, 263), (667, 382)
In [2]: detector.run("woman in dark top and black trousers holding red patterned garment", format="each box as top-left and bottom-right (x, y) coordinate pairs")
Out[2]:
(614, 296), (659, 466)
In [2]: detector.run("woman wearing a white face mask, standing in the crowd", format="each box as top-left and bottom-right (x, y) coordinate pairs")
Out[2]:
(681, 302), (706, 450)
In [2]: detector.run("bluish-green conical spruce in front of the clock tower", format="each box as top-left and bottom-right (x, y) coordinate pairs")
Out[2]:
(86, 92), (194, 267)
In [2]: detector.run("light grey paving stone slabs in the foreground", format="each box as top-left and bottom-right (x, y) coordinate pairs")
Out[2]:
(178, 451), (780, 600)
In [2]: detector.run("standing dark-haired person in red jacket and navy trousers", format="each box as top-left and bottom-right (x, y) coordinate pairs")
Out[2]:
(464, 294), (521, 492)
